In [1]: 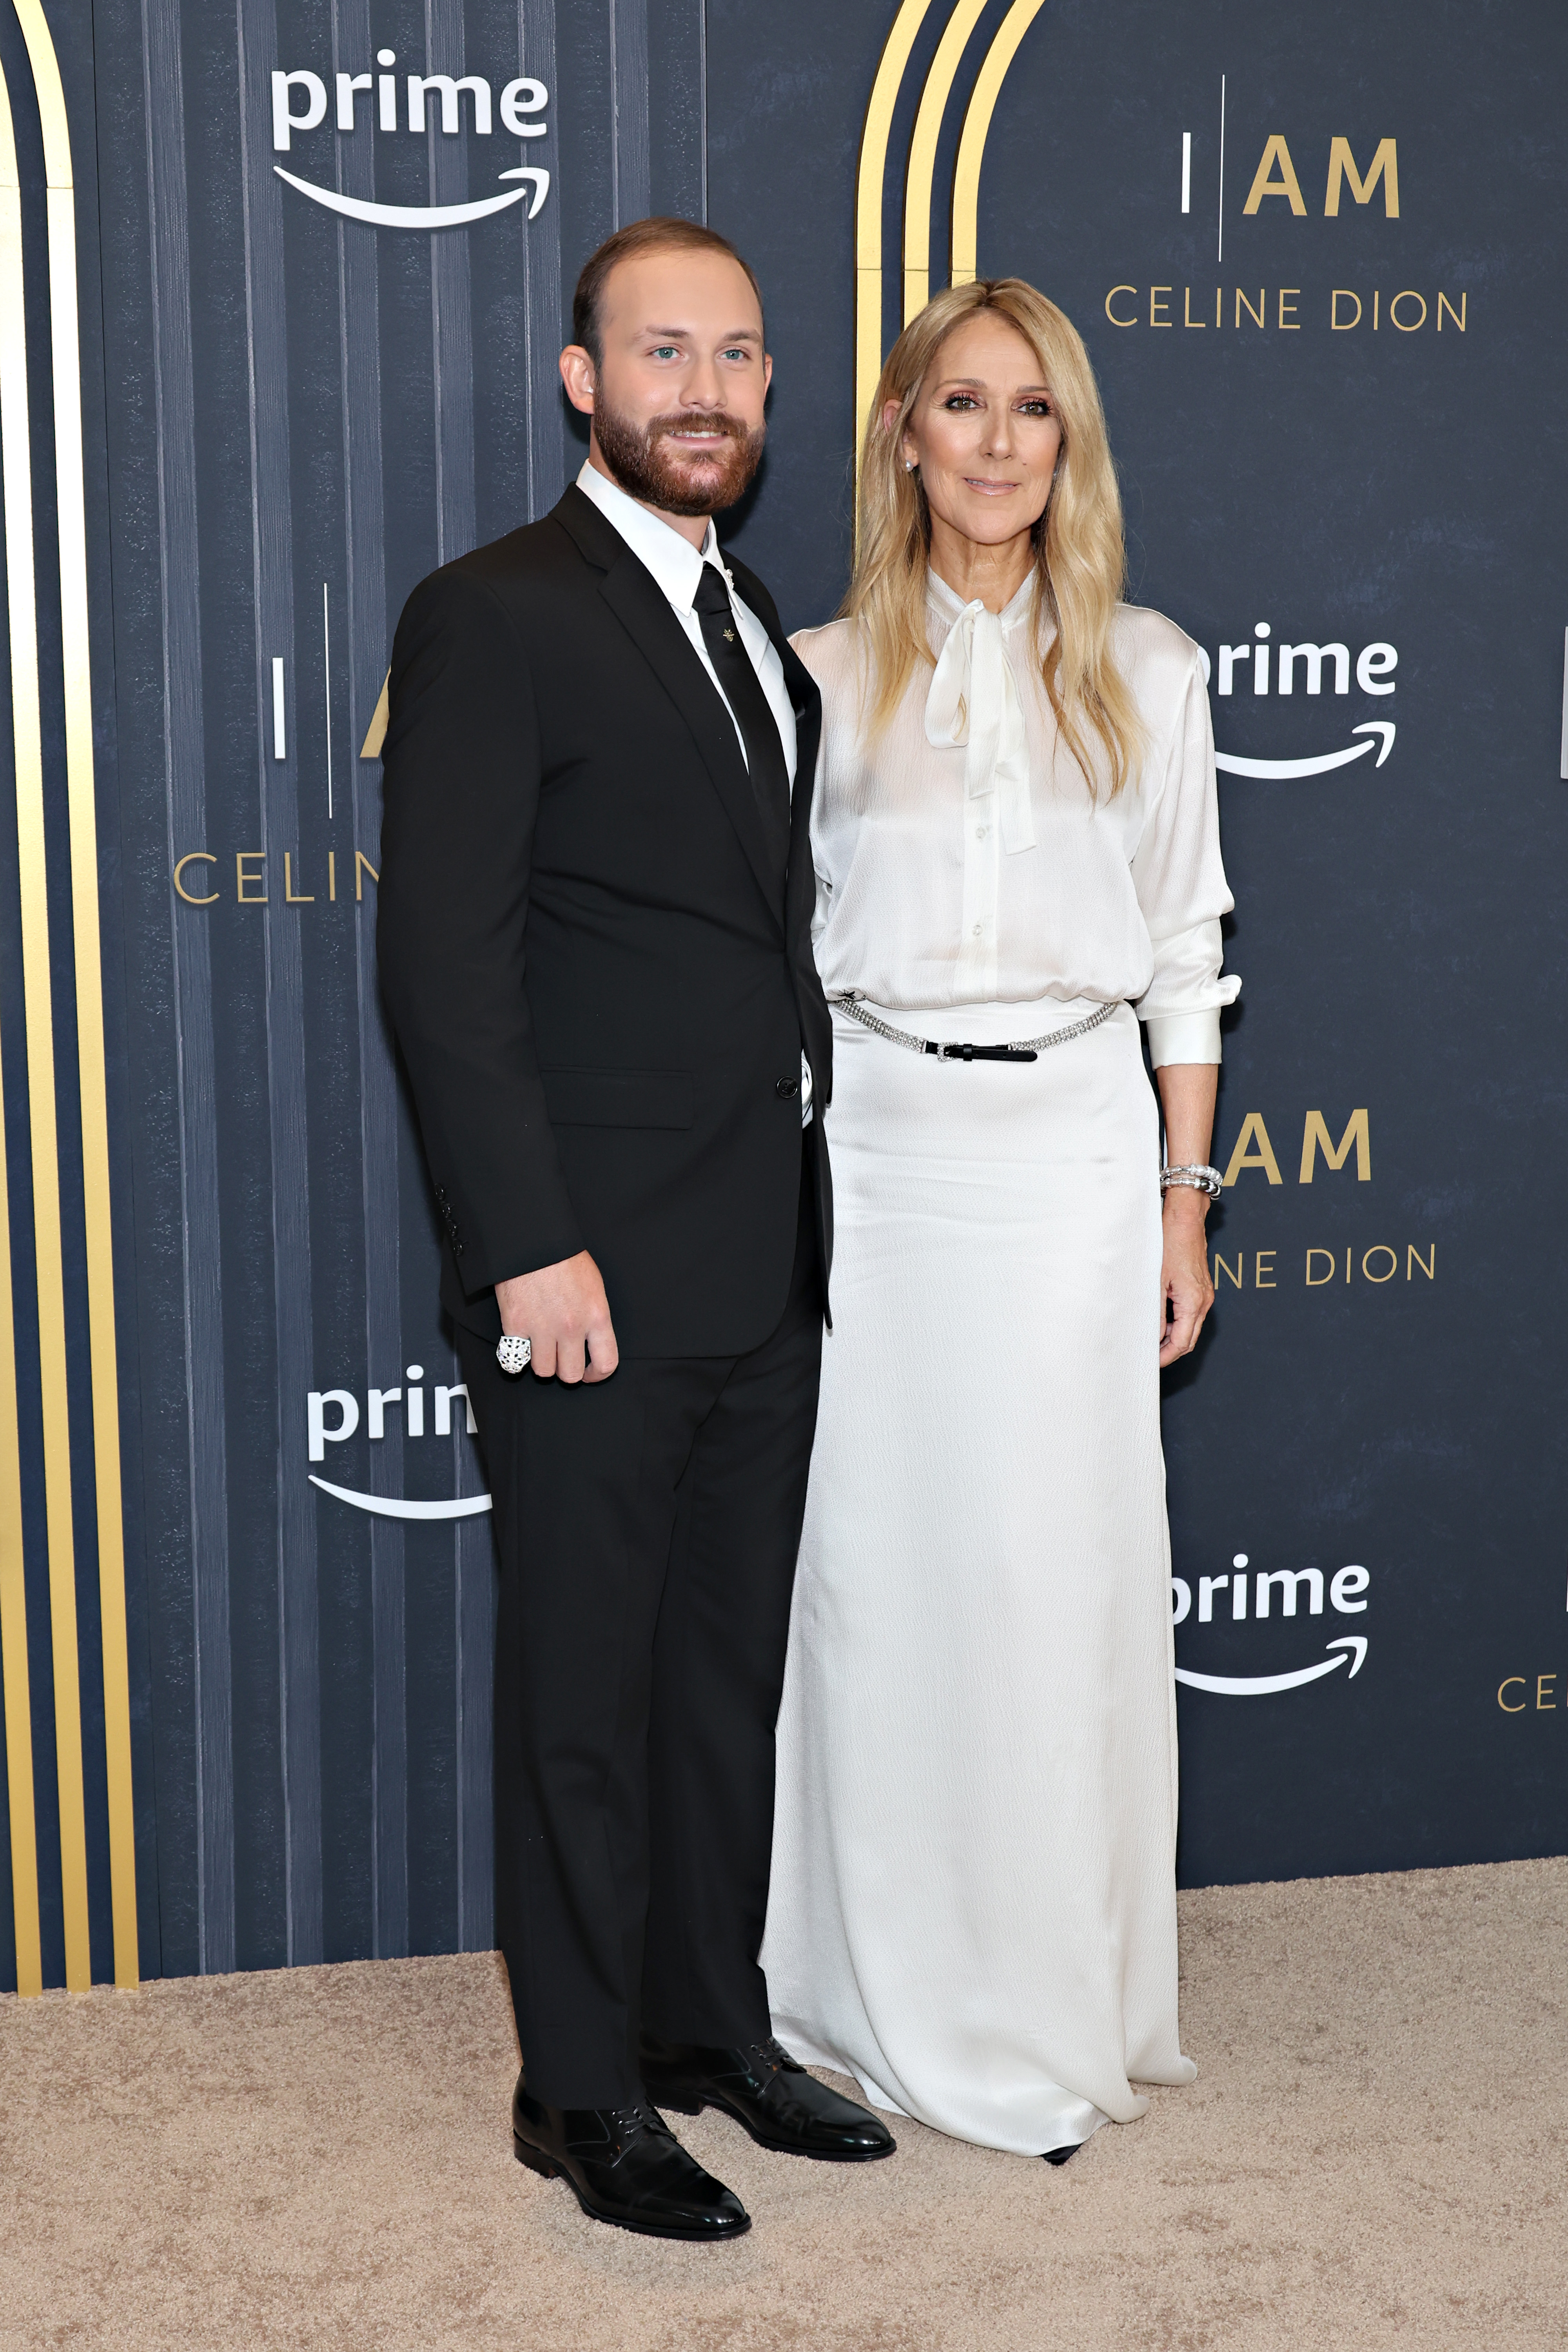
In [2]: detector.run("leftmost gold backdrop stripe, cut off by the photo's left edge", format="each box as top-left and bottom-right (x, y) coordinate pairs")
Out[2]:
(0, 66), (45, 1994)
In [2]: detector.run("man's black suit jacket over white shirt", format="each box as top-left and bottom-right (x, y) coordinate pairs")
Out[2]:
(376, 487), (832, 1355)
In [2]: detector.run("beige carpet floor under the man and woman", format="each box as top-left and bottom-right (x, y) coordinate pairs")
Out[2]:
(0, 1860), (1568, 2352)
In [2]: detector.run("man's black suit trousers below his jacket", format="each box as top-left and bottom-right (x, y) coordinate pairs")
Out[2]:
(458, 1181), (823, 2107)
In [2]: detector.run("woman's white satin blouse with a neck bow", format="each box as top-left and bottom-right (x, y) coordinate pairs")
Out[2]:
(790, 574), (1241, 1065)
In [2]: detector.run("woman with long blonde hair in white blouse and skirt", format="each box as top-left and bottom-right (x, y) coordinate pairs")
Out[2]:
(762, 278), (1239, 2164)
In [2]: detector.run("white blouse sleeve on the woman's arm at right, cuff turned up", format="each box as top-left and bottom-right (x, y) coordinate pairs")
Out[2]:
(1133, 654), (1241, 1068)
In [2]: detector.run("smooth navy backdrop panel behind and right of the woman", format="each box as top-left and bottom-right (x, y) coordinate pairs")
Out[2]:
(710, 0), (1568, 1882)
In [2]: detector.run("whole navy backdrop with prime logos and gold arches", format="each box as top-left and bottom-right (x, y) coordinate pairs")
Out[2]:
(0, 0), (1568, 1990)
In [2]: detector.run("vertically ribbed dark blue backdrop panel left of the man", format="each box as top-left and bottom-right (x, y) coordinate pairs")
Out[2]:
(85, 0), (703, 1971)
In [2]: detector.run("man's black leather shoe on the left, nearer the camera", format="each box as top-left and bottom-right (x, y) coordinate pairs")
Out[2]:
(512, 2077), (752, 2244)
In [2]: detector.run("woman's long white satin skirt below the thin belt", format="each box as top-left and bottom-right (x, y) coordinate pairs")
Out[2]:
(762, 1002), (1194, 2154)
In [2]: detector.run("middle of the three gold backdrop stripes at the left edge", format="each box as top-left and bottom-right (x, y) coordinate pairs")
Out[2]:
(0, 32), (92, 1992)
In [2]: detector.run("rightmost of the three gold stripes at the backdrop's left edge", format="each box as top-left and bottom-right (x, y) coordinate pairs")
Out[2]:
(14, 0), (139, 1985)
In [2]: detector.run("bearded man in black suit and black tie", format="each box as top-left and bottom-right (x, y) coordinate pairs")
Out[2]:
(379, 221), (893, 2239)
